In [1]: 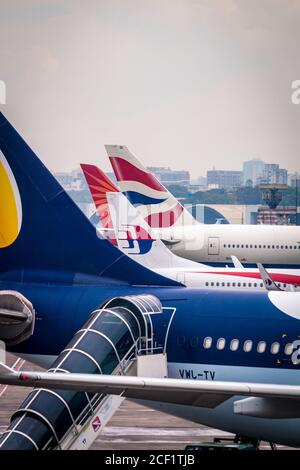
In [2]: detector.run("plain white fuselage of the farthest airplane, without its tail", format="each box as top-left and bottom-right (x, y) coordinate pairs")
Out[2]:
(157, 224), (300, 268)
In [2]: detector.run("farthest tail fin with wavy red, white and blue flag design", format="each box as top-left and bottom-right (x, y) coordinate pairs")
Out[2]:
(105, 145), (198, 229)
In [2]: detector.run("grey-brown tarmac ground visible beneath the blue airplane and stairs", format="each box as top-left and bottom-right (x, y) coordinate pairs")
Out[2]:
(0, 355), (292, 450)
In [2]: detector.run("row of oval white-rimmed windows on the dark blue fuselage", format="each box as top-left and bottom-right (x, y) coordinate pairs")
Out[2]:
(203, 336), (293, 356)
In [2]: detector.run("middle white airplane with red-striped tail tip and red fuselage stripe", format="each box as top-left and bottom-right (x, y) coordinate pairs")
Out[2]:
(81, 164), (300, 290)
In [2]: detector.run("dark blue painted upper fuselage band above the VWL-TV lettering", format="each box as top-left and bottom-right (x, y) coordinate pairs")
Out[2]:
(0, 280), (300, 370)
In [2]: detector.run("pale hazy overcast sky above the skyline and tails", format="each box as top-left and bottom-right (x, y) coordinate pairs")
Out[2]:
(0, 0), (300, 177)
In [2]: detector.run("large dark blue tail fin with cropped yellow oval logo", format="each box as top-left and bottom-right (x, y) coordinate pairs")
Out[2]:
(0, 113), (176, 285)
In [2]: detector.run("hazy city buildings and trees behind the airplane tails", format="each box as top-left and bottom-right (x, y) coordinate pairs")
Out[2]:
(54, 155), (300, 225)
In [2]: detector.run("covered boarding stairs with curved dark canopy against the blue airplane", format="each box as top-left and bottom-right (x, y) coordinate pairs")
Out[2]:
(0, 295), (167, 450)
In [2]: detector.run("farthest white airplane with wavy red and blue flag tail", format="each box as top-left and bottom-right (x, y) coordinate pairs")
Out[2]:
(106, 145), (300, 268)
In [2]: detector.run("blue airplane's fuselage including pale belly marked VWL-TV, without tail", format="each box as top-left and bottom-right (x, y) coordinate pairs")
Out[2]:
(0, 272), (300, 446)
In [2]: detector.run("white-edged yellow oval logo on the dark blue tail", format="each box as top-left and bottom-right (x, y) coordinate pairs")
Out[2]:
(0, 151), (22, 249)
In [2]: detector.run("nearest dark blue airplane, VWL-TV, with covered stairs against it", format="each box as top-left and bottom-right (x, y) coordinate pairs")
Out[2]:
(0, 114), (300, 450)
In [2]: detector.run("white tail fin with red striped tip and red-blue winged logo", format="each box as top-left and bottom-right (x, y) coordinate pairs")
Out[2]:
(81, 164), (199, 269)
